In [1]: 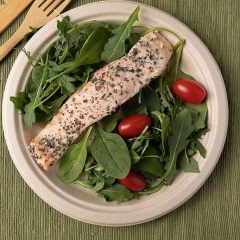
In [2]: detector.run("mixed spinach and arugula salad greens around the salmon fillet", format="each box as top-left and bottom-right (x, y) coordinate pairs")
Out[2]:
(11, 7), (208, 202)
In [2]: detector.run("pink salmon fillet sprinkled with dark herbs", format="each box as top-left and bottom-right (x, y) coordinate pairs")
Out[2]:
(28, 32), (173, 170)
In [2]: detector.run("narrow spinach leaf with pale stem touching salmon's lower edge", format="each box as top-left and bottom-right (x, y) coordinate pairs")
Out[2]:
(57, 127), (92, 182)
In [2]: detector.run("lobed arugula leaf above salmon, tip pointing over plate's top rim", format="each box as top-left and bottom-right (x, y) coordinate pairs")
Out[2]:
(102, 6), (140, 62)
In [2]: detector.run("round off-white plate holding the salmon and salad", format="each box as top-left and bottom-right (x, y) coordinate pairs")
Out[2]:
(3, 1), (228, 226)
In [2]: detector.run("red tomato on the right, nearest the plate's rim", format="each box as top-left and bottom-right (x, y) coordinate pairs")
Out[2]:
(173, 78), (206, 104)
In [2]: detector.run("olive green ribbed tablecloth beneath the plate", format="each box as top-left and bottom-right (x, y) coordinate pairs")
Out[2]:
(0, 0), (240, 240)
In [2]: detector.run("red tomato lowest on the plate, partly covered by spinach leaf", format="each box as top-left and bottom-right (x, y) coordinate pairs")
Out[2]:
(118, 170), (146, 192)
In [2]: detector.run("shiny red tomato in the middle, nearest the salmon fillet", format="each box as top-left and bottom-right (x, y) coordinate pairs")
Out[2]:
(118, 114), (151, 138)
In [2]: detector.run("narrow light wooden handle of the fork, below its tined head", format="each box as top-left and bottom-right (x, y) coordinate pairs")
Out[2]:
(0, 25), (30, 62)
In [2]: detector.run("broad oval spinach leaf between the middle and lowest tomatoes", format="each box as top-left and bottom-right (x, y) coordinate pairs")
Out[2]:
(90, 126), (131, 178)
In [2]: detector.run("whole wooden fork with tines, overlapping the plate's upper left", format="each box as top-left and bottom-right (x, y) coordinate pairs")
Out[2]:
(0, 0), (71, 62)
